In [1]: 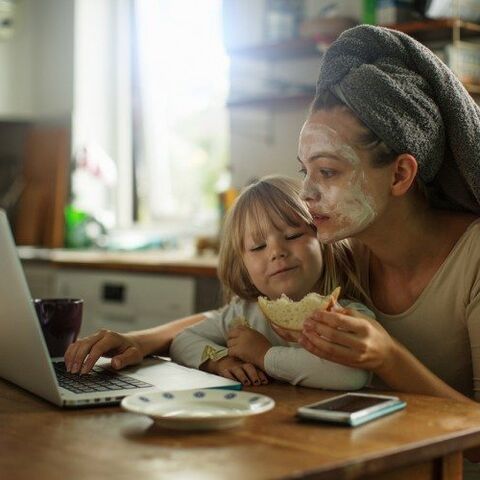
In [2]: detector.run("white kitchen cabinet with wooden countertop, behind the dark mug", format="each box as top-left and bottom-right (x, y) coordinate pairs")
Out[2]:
(20, 255), (222, 336)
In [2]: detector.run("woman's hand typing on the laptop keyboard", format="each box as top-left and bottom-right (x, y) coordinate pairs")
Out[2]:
(64, 329), (145, 374)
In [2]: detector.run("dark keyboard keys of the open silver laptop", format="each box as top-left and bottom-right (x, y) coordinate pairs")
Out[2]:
(53, 362), (153, 393)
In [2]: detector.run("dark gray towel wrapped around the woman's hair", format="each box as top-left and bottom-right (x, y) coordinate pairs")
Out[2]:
(316, 25), (480, 214)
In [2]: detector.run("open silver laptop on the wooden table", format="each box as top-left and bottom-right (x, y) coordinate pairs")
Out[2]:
(0, 210), (241, 407)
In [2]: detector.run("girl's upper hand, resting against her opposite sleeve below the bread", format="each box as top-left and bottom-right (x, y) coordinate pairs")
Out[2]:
(227, 326), (272, 370)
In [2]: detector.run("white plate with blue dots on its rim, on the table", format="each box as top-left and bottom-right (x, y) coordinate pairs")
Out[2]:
(121, 388), (275, 430)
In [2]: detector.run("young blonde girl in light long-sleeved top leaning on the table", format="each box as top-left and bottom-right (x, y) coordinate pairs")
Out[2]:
(170, 176), (372, 390)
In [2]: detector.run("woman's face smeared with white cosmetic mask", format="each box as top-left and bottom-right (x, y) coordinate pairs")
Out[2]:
(298, 120), (377, 243)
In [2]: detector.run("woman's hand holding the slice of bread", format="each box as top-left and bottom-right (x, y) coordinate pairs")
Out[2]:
(298, 308), (395, 375)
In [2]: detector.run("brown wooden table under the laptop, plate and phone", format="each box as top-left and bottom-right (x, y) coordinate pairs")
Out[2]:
(0, 380), (480, 480)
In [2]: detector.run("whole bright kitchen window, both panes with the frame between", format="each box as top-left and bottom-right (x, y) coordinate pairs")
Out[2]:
(72, 0), (228, 240)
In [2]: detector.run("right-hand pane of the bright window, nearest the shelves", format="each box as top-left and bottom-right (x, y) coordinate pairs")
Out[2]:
(132, 0), (228, 231)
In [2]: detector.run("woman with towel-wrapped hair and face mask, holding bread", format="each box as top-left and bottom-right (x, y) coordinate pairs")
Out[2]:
(283, 26), (480, 468)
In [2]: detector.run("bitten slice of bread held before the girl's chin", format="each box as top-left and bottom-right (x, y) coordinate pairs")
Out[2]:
(258, 287), (340, 331)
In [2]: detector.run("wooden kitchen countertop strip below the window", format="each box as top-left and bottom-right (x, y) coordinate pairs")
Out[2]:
(17, 246), (218, 277)
